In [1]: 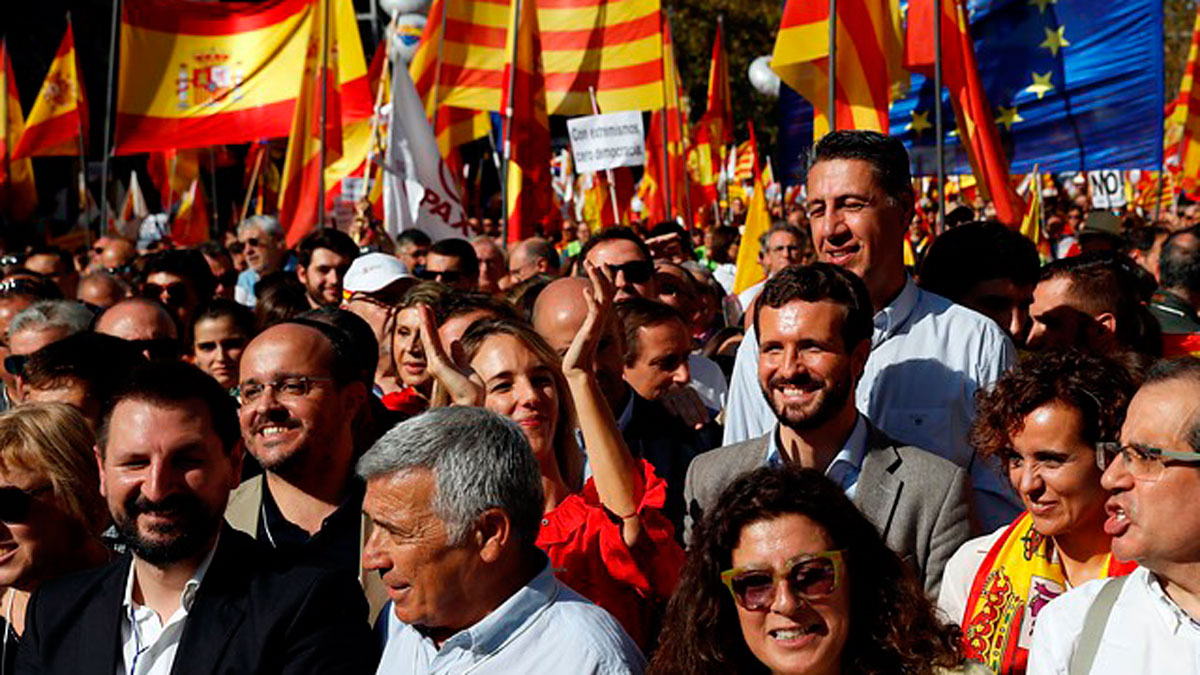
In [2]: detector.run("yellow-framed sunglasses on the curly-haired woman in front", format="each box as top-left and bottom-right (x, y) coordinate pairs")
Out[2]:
(721, 551), (845, 611)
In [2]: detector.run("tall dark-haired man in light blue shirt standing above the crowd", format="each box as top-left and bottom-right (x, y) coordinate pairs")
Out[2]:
(725, 131), (1021, 531)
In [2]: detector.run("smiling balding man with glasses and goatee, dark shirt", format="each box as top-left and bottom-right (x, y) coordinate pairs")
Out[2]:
(226, 318), (386, 617)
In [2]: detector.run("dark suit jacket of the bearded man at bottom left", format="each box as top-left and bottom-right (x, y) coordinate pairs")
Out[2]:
(17, 526), (379, 675)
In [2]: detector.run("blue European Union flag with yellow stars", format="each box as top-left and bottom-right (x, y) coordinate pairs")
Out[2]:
(780, 0), (1163, 181)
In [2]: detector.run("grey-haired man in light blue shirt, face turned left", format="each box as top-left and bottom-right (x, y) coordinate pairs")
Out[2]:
(358, 407), (644, 675)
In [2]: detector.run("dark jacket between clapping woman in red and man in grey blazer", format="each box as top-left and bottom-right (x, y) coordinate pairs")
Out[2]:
(622, 388), (721, 542)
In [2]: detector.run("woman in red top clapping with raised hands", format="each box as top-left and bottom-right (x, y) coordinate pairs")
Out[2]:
(420, 265), (683, 649)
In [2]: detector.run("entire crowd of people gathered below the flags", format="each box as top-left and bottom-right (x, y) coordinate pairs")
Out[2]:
(0, 131), (1200, 675)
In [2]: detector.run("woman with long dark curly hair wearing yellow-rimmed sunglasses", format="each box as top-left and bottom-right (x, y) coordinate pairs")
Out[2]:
(650, 466), (983, 675)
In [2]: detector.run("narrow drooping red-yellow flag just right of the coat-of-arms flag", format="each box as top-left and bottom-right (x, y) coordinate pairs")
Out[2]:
(280, 0), (357, 246)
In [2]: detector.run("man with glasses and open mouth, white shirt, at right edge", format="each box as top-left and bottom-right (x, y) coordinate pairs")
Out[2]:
(1028, 357), (1200, 675)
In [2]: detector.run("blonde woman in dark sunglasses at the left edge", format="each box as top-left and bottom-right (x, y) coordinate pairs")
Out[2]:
(0, 404), (109, 675)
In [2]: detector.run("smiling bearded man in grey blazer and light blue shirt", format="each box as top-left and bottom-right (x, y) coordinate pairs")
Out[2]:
(684, 263), (971, 596)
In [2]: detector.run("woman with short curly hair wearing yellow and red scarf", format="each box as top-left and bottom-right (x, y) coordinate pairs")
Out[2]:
(937, 351), (1136, 675)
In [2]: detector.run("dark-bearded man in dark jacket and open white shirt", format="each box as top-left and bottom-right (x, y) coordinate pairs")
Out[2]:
(17, 363), (377, 675)
